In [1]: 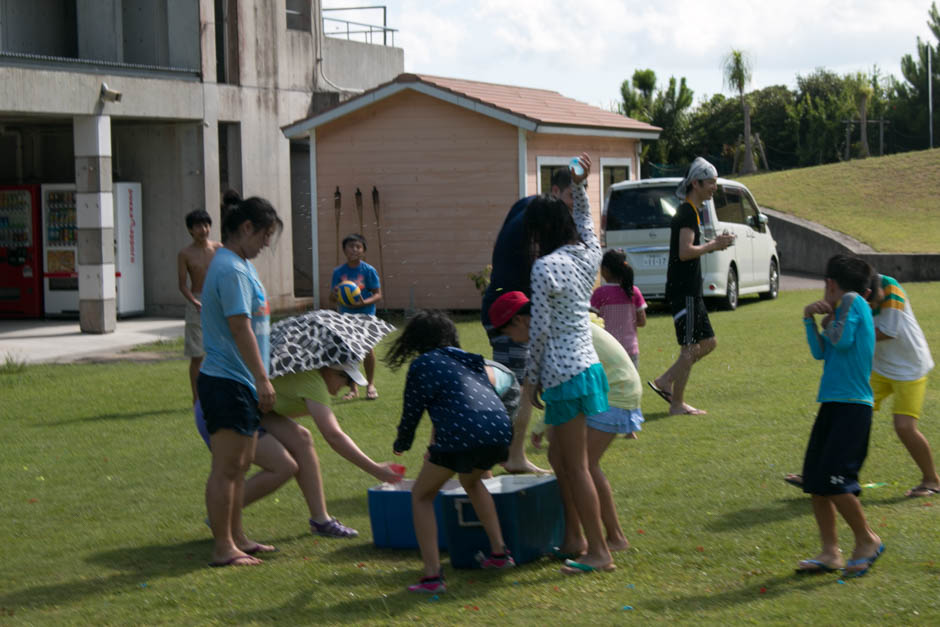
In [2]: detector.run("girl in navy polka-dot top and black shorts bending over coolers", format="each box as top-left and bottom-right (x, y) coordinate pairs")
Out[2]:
(385, 311), (515, 593)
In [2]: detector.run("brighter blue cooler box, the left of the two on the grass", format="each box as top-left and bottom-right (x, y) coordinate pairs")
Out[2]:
(369, 479), (460, 549)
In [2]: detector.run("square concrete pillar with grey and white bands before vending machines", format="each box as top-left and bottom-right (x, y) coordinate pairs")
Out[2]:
(73, 115), (117, 333)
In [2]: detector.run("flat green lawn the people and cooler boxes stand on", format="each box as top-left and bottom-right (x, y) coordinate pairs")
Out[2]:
(0, 283), (940, 625)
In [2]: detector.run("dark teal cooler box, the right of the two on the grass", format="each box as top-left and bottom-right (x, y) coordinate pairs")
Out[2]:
(438, 475), (565, 568)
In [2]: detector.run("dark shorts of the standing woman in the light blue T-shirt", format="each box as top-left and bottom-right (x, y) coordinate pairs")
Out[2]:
(196, 372), (261, 437)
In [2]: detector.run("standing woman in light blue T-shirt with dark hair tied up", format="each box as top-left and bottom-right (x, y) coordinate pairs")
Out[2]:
(197, 191), (283, 566)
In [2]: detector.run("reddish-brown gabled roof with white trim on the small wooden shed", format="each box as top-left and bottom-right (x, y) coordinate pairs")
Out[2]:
(282, 74), (662, 139)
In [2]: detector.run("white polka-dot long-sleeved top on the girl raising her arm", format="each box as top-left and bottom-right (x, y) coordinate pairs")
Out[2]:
(526, 185), (601, 390)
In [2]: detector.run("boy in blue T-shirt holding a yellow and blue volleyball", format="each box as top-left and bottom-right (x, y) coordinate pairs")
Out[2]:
(330, 233), (382, 401)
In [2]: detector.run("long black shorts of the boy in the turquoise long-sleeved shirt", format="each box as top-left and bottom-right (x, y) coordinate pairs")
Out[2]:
(803, 403), (872, 496)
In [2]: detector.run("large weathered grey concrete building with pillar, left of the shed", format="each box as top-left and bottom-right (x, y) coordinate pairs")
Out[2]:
(0, 0), (404, 333)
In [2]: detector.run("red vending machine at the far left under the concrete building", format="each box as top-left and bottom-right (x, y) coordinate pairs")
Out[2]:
(0, 185), (43, 318)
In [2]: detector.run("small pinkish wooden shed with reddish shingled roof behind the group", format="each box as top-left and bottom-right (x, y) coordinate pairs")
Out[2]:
(283, 74), (660, 309)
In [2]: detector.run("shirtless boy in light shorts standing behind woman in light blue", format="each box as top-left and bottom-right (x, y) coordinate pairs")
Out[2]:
(176, 209), (222, 405)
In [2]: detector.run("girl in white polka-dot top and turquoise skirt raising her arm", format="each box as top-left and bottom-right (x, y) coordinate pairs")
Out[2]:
(525, 154), (615, 575)
